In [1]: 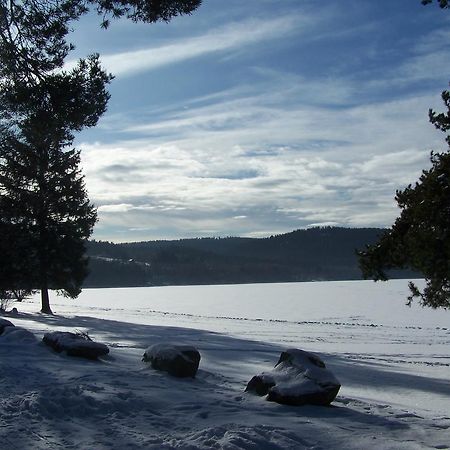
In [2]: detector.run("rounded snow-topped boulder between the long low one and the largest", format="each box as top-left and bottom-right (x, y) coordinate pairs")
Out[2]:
(142, 344), (200, 378)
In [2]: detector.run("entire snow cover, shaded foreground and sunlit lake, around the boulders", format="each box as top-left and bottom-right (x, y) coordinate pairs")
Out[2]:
(0, 281), (450, 450)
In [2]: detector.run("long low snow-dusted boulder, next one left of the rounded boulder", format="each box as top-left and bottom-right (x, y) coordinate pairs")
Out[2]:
(42, 331), (109, 359)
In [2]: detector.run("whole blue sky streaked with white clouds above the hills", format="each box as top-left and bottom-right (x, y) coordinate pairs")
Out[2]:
(69, 0), (450, 242)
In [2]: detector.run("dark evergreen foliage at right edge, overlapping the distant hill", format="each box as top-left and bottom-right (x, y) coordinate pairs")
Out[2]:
(359, 91), (450, 308)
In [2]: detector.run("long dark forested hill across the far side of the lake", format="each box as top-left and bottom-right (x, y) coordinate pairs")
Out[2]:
(85, 227), (413, 287)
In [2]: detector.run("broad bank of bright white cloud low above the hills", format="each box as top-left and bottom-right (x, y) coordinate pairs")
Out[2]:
(82, 85), (442, 238)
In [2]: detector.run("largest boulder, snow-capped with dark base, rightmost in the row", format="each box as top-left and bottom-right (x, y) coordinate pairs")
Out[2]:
(245, 349), (341, 406)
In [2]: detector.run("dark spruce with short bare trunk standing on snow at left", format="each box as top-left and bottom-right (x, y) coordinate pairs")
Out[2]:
(0, 128), (96, 313)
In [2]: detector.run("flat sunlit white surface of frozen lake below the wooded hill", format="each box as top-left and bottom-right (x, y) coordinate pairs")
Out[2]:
(40, 280), (450, 327)
